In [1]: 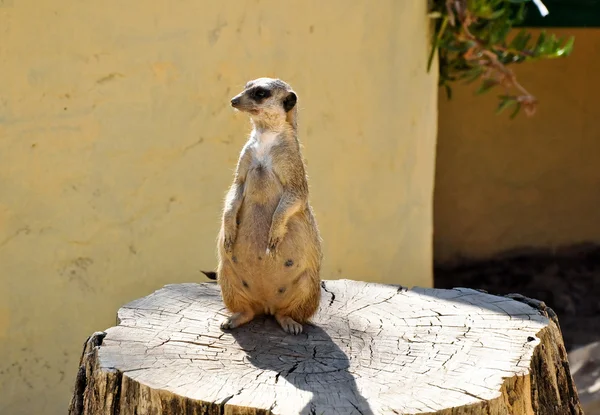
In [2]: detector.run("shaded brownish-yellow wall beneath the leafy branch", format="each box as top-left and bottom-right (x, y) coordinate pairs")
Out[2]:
(434, 29), (600, 261)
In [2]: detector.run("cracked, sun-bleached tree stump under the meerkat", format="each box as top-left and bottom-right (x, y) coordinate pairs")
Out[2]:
(69, 280), (583, 415)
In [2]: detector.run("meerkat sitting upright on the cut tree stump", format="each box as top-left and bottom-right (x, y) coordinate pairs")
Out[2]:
(205, 78), (322, 334)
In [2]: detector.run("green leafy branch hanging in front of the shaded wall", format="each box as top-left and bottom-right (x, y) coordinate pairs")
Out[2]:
(428, 0), (575, 118)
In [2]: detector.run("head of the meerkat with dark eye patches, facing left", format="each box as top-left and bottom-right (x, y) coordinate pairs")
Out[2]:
(231, 78), (298, 129)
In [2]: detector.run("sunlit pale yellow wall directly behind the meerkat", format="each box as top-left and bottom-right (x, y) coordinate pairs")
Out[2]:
(0, 0), (437, 415)
